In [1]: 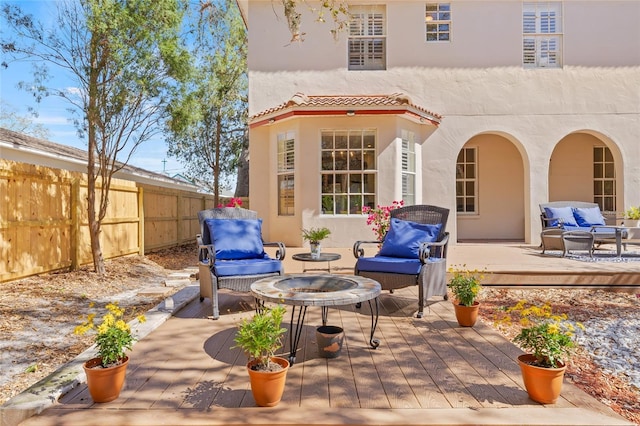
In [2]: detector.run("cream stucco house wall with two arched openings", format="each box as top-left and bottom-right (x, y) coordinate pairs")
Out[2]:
(247, 0), (640, 246)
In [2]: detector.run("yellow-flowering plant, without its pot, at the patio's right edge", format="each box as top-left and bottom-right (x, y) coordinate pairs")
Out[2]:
(498, 300), (584, 368)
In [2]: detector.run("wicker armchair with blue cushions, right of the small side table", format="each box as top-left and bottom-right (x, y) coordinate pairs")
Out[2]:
(353, 205), (449, 318)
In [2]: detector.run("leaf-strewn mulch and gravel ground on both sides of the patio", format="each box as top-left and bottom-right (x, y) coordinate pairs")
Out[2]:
(0, 246), (640, 424)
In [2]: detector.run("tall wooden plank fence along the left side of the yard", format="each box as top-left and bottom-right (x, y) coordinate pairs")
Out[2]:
(0, 159), (238, 282)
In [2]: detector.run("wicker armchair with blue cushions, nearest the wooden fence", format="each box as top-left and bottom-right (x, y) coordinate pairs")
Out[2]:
(196, 207), (285, 319)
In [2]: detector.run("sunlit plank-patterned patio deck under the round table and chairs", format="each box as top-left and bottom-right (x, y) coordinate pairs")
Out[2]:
(23, 288), (629, 425)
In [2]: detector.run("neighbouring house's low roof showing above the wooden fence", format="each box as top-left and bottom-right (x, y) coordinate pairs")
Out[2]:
(0, 127), (198, 191)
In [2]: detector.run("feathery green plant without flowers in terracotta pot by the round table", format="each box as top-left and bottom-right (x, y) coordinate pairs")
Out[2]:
(232, 305), (289, 407)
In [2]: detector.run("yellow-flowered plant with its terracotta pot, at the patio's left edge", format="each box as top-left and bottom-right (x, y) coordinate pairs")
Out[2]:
(74, 302), (146, 402)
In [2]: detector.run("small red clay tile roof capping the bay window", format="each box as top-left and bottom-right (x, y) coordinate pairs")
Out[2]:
(249, 92), (442, 125)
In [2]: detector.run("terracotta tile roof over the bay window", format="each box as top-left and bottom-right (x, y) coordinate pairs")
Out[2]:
(249, 92), (442, 127)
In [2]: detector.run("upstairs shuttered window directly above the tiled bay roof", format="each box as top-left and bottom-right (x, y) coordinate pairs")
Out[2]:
(348, 6), (387, 70)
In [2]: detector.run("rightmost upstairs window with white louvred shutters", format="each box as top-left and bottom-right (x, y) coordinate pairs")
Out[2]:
(522, 1), (562, 68)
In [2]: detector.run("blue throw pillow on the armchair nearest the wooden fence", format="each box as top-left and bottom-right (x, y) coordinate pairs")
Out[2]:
(204, 219), (264, 260)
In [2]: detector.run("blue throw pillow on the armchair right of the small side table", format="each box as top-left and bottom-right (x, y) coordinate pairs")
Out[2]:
(379, 218), (442, 259)
